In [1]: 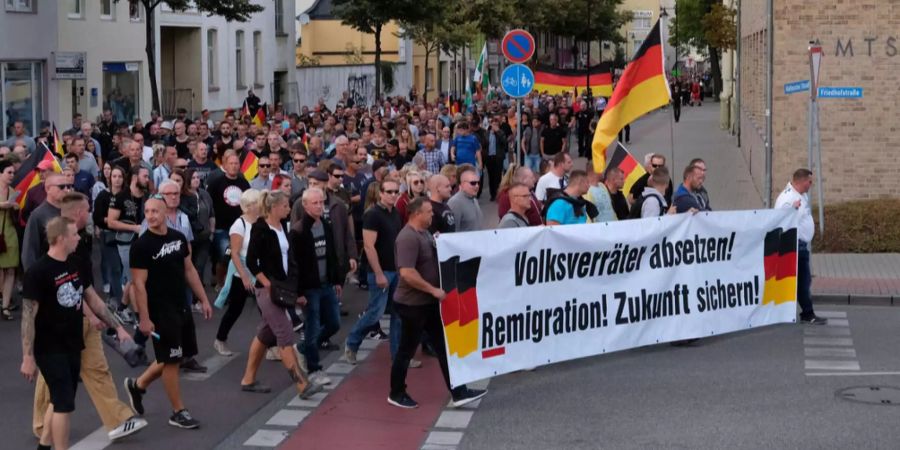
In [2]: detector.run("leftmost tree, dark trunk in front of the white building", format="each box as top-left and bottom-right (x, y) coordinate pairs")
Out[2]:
(115, 0), (265, 111)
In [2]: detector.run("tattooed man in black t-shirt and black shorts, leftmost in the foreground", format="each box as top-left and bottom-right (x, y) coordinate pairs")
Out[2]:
(20, 217), (131, 448)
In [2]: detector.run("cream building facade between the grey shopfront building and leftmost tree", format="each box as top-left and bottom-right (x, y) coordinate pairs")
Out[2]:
(57, 0), (152, 126)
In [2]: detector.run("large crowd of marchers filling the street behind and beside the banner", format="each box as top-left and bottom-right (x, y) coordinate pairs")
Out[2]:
(0, 85), (819, 449)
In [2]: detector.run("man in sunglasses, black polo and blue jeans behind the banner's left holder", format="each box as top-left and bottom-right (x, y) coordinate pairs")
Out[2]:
(344, 180), (403, 364)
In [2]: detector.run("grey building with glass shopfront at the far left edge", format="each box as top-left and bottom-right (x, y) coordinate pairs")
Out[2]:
(0, 0), (59, 140)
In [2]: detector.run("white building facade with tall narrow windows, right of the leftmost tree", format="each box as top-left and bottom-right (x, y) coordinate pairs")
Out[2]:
(157, 0), (278, 113)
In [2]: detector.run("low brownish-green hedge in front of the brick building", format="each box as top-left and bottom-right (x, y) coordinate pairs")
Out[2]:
(813, 199), (900, 253)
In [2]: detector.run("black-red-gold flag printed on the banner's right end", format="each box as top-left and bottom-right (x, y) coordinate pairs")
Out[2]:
(763, 228), (797, 305)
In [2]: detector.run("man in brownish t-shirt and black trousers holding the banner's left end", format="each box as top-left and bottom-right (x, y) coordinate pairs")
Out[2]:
(387, 197), (487, 409)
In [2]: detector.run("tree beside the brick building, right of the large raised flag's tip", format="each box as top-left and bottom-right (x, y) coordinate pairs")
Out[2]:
(669, 0), (737, 97)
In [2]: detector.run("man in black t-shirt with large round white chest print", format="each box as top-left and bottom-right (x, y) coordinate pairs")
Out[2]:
(206, 150), (250, 286)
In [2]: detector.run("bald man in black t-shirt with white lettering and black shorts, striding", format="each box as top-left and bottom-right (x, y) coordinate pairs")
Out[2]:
(125, 198), (212, 429)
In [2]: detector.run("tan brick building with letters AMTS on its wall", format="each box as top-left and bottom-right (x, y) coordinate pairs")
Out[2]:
(740, 0), (900, 203)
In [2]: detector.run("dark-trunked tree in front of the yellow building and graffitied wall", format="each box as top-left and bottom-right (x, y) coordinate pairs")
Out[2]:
(333, 0), (430, 100)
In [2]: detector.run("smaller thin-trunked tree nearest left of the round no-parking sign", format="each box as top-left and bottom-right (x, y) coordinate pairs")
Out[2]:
(400, 0), (476, 102)
